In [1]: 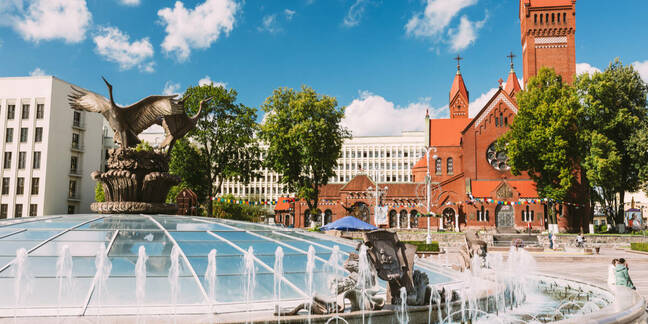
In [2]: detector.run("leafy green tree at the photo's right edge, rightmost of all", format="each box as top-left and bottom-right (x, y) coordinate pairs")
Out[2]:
(575, 59), (648, 223)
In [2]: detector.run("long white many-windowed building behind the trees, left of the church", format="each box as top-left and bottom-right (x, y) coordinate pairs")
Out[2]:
(140, 130), (425, 200)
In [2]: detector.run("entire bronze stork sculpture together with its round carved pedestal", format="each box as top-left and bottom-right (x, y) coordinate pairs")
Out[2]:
(68, 79), (209, 214)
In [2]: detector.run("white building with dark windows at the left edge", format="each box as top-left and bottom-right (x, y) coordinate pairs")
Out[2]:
(0, 76), (104, 218)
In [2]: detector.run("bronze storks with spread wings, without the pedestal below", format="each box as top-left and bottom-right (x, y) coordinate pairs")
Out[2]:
(68, 77), (205, 152)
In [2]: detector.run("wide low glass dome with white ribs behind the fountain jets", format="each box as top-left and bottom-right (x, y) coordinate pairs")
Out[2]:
(0, 215), (451, 317)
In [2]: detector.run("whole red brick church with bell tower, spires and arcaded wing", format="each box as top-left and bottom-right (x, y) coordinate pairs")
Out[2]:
(275, 0), (581, 230)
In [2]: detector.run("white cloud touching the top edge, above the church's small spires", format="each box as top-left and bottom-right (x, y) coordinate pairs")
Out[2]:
(405, 0), (477, 38)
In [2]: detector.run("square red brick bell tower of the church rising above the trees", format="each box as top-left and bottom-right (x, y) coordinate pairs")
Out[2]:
(520, 0), (576, 84)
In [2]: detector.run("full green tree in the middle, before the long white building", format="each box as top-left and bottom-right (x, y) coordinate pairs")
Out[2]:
(259, 86), (350, 216)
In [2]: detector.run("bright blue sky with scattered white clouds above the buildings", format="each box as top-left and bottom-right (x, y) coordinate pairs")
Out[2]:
(0, 0), (648, 135)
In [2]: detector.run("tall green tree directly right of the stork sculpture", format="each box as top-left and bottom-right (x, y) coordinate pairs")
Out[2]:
(172, 84), (261, 217)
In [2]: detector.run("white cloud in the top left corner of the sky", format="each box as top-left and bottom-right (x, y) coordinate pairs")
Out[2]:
(7, 0), (92, 43)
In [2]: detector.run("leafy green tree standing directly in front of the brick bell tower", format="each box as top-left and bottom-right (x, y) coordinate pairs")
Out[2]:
(499, 68), (583, 223)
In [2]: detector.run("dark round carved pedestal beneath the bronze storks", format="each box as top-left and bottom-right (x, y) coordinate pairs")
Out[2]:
(90, 148), (180, 214)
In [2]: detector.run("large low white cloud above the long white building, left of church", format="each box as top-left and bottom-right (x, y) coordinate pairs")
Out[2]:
(342, 91), (448, 136)
